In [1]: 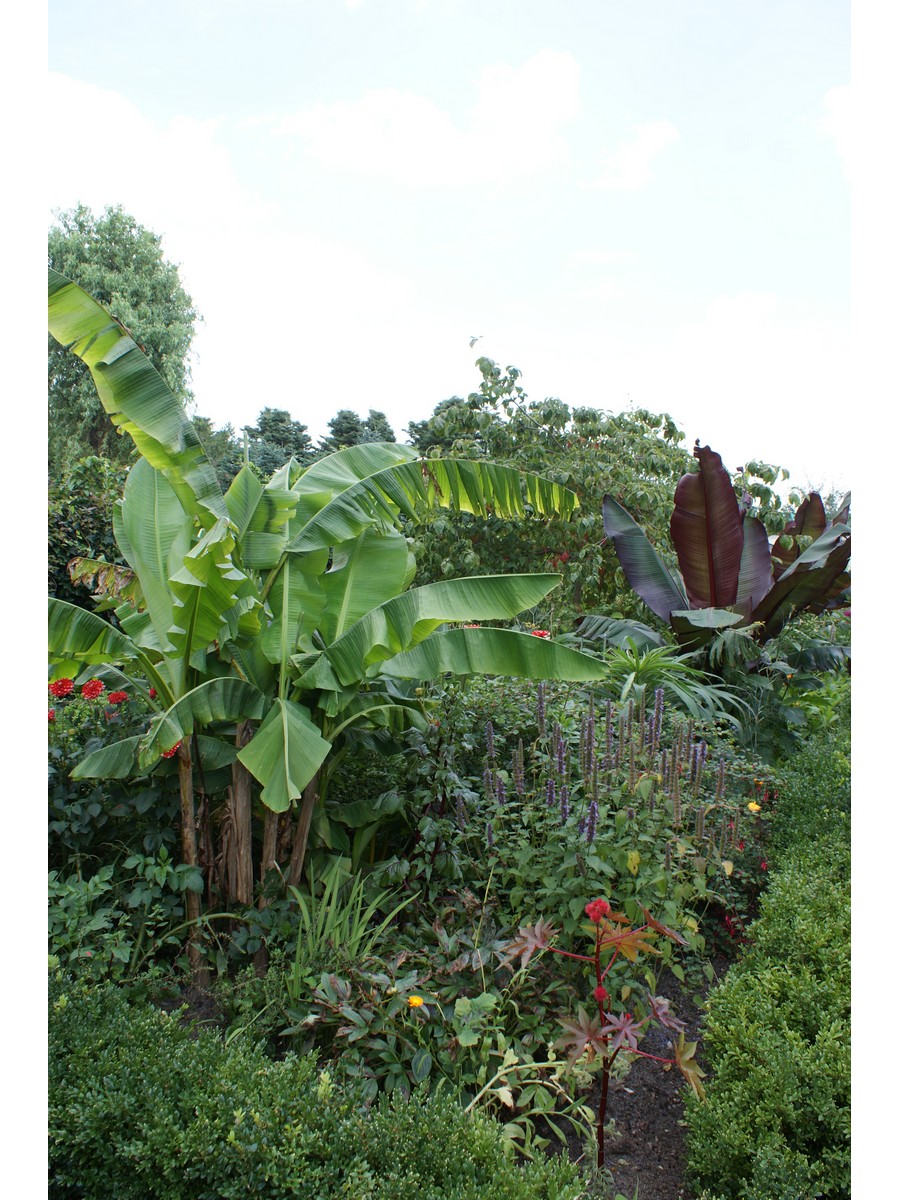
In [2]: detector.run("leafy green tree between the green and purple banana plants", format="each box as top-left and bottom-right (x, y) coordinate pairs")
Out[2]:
(409, 358), (690, 631)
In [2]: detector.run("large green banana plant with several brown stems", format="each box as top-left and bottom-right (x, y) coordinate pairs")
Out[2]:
(48, 270), (602, 916)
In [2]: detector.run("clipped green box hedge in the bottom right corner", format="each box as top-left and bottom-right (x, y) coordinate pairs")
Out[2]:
(688, 834), (850, 1200)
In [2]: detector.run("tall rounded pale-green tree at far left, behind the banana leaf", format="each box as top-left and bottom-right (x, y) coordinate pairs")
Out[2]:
(47, 204), (200, 478)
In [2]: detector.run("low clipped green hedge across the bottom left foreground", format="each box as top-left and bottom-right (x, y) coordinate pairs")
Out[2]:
(49, 973), (582, 1200)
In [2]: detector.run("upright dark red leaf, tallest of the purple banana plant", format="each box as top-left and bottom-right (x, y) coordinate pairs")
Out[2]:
(670, 446), (744, 608)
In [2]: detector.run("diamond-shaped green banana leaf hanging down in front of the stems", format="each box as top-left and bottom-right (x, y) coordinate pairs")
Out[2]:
(238, 700), (331, 812)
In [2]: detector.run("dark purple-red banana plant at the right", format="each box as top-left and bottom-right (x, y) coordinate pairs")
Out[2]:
(604, 445), (851, 647)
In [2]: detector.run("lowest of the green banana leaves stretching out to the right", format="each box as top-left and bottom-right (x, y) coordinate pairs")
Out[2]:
(379, 629), (606, 683)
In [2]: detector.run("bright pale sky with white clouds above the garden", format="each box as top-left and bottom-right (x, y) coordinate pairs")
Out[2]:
(47, 0), (852, 491)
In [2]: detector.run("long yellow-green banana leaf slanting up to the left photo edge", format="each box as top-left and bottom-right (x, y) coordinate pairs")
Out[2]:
(48, 268), (227, 527)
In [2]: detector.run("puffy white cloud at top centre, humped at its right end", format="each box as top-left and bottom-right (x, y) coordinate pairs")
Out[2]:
(274, 50), (580, 187)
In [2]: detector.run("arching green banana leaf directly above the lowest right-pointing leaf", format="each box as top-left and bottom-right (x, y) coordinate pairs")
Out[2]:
(324, 575), (562, 684)
